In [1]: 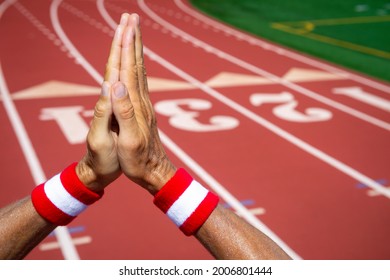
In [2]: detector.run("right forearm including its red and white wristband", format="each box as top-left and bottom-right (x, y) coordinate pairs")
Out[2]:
(154, 168), (289, 260)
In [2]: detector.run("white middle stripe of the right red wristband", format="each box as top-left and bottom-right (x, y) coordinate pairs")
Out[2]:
(167, 180), (208, 227)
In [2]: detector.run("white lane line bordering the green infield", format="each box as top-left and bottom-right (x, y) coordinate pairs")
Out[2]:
(174, 0), (390, 93)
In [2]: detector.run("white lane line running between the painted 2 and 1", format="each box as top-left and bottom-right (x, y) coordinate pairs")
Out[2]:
(137, 0), (390, 131)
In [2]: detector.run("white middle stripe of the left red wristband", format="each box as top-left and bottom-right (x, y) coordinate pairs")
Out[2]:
(44, 174), (88, 217)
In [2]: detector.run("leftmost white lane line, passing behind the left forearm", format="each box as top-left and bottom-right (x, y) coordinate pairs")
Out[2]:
(0, 0), (79, 260)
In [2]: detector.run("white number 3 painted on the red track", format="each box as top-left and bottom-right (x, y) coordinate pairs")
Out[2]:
(154, 98), (239, 132)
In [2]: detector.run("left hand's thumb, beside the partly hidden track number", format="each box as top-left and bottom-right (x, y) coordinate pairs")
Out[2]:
(88, 81), (112, 146)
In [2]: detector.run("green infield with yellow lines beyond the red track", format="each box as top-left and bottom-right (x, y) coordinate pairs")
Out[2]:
(191, 0), (390, 81)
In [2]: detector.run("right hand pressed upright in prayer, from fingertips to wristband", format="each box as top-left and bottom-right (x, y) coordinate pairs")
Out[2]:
(106, 14), (176, 194)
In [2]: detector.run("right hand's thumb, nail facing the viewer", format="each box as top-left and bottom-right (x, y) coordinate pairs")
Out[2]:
(111, 82), (138, 135)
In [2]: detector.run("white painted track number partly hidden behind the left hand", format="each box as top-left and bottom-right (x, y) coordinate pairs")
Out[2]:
(39, 106), (93, 145)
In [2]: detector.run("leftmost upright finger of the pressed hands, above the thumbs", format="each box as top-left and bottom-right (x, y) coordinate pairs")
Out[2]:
(104, 13), (129, 84)
